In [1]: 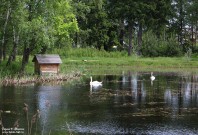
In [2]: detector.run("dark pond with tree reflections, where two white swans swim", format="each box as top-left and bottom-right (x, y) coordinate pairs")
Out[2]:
(0, 71), (198, 135)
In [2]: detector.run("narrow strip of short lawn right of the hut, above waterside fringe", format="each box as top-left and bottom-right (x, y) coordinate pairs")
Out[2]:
(62, 57), (198, 68)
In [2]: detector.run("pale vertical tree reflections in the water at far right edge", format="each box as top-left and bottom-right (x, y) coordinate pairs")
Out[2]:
(164, 75), (198, 115)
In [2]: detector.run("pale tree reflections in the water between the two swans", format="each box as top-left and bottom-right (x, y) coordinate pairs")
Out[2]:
(103, 71), (146, 104)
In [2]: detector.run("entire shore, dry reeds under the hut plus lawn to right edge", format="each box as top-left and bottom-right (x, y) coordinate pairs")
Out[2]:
(0, 57), (198, 85)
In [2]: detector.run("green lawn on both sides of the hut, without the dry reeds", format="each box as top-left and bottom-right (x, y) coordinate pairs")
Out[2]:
(0, 55), (198, 78)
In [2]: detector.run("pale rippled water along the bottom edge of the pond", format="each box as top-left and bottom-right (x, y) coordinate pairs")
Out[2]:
(61, 122), (198, 135)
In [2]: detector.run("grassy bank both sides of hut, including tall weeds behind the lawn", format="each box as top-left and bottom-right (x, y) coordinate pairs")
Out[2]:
(0, 48), (198, 83)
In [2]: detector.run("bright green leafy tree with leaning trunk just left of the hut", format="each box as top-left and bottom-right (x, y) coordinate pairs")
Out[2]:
(21, 0), (78, 72)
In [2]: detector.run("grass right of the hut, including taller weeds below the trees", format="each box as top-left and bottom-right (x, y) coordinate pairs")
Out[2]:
(51, 48), (198, 68)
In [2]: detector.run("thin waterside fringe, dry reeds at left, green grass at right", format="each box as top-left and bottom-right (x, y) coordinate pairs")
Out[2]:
(0, 64), (198, 86)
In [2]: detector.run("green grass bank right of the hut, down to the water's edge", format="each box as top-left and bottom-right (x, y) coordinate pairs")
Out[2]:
(61, 57), (198, 75)
